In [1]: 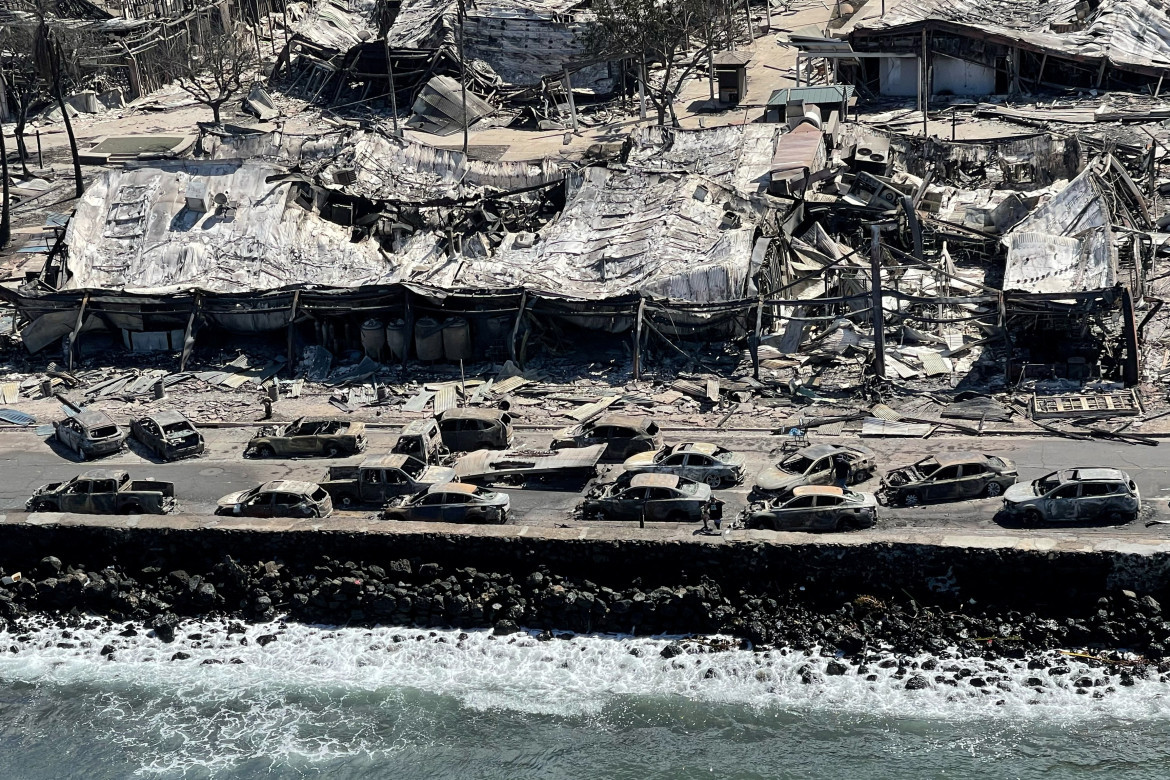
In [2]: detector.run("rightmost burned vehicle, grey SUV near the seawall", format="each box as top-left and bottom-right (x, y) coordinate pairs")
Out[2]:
(1004, 467), (1142, 525)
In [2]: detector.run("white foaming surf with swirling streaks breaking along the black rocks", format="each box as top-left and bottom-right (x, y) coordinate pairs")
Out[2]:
(0, 621), (1170, 776)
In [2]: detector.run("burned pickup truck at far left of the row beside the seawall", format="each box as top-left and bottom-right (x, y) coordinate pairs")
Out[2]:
(25, 471), (174, 515)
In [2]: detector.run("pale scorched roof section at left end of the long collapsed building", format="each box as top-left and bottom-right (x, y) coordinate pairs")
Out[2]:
(60, 160), (394, 292)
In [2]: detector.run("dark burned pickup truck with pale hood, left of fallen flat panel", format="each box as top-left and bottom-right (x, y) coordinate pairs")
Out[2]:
(319, 454), (455, 508)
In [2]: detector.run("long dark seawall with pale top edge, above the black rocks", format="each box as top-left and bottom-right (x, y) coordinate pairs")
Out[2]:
(0, 515), (1170, 612)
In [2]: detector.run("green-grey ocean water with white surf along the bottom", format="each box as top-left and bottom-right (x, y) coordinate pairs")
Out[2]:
(0, 623), (1170, 780)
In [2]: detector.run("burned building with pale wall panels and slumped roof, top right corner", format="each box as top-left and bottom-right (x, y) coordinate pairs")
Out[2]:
(851, 0), (1170, 96)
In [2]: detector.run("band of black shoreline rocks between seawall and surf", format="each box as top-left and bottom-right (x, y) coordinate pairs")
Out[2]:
(0, 555), (1170, 690)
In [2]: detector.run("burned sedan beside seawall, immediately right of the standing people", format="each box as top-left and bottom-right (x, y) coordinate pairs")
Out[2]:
(743, 485), (878, 531)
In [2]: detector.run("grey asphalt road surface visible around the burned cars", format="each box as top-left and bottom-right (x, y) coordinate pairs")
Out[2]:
(0, 428), (1170, 537)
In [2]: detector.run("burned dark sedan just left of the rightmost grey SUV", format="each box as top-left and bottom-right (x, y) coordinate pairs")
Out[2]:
(881, 453), (1017, 506)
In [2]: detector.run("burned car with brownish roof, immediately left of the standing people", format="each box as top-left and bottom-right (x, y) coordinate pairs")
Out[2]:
(580, 474), (723, 523)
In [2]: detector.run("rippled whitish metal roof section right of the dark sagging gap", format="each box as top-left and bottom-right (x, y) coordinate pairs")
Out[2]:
(414, 167), (763, 303)
